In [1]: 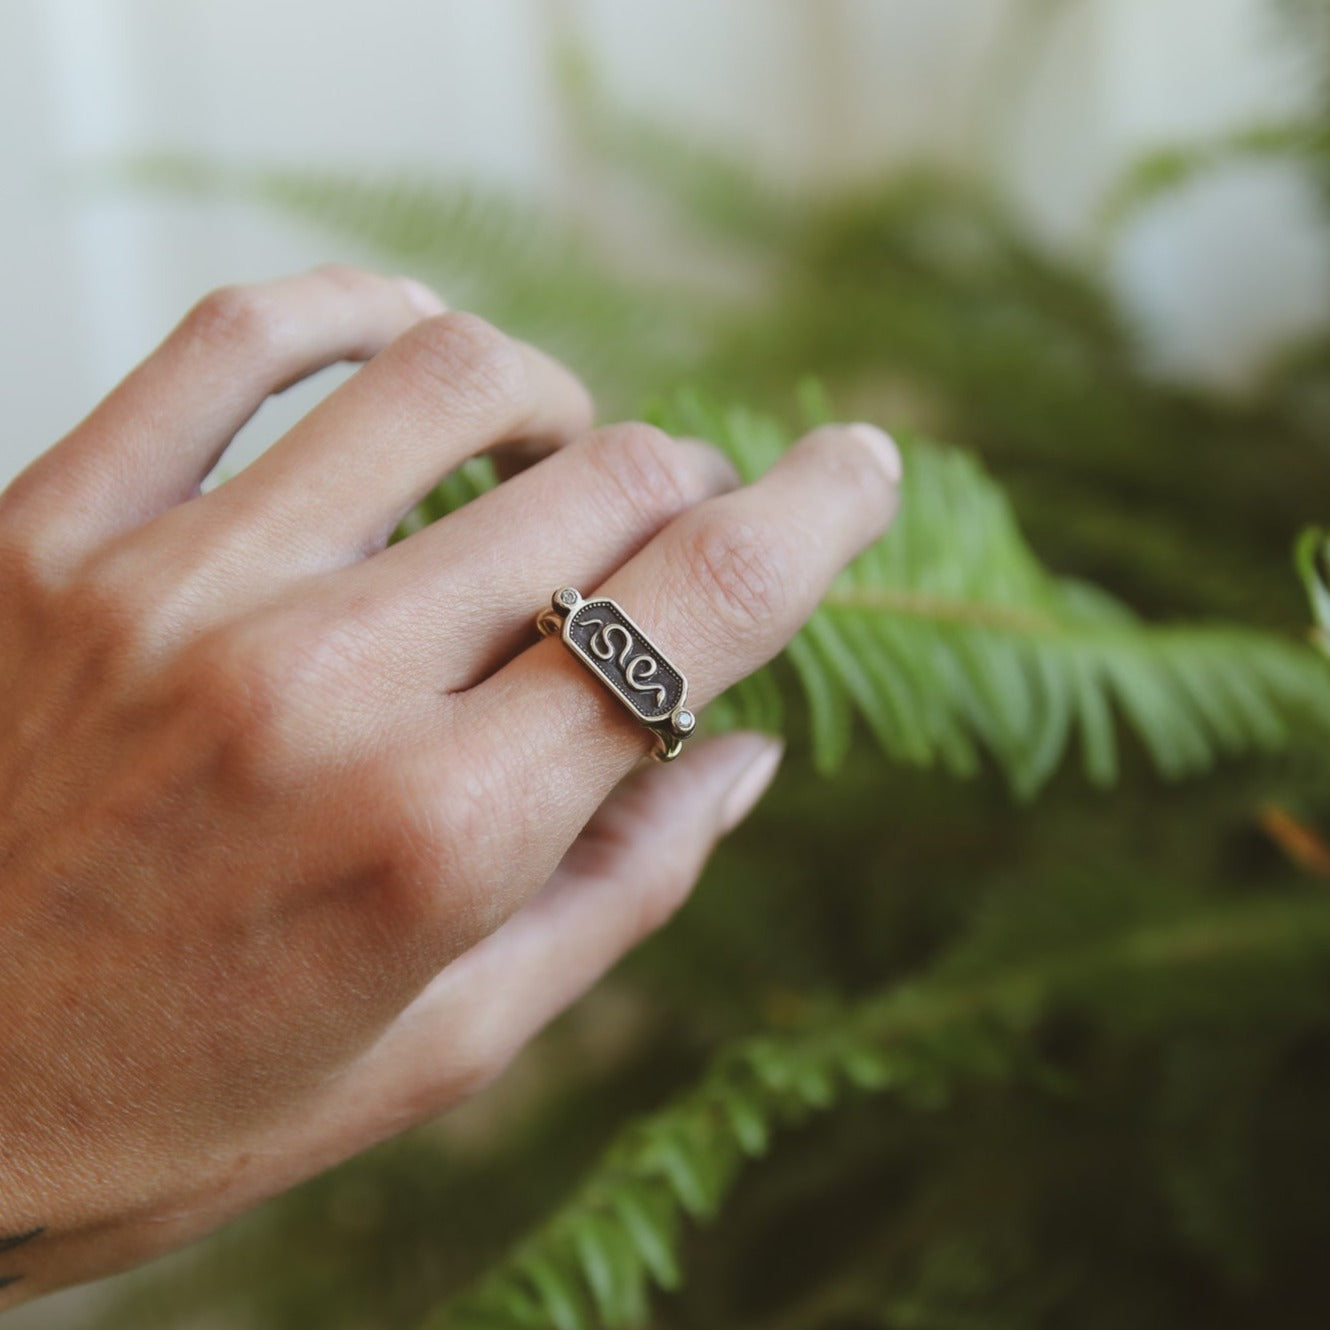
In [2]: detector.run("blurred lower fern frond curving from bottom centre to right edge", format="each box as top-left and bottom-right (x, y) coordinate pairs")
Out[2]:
(427, 896), (1330, 1330)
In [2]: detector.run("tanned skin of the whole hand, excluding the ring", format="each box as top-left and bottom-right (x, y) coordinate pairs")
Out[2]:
(0, 267), (900, 1309)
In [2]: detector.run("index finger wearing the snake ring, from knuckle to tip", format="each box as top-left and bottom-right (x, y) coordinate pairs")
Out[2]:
(388, 426), (900, 936)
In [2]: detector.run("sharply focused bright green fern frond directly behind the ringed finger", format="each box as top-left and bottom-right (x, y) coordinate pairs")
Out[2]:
(657, 395), (1330, 797)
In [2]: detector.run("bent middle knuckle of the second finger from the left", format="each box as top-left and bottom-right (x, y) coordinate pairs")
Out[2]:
(391, 311), (529, 423)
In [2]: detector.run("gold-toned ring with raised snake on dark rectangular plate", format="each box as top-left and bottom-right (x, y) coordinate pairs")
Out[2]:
(536, 587), (697, 762)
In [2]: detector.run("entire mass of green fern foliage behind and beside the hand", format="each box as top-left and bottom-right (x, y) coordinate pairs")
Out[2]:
(86, 10), (1330, 1330)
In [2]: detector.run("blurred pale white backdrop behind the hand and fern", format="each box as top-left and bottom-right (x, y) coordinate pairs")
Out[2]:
(0, 0), (1330, 481)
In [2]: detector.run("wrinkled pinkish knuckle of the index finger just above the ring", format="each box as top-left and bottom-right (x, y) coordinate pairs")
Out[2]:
(684, 508), (793, 632)
